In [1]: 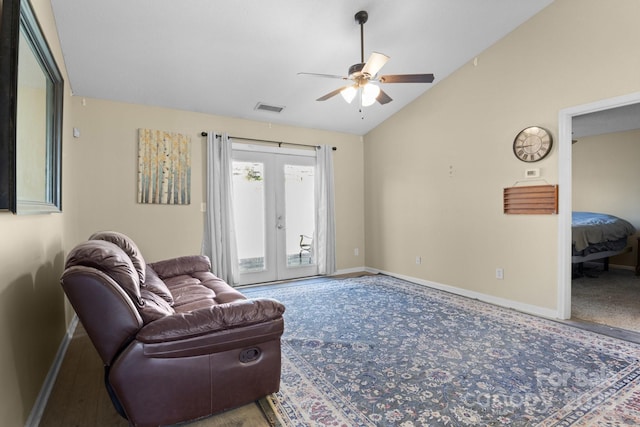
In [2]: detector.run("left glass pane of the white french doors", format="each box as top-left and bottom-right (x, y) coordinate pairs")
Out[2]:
(233, 161), (266, 273)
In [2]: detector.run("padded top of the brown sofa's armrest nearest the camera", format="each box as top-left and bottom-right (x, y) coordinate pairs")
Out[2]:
(136, 298), (285, 344)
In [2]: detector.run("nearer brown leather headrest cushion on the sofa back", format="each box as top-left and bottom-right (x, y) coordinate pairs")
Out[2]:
(65, 240), (142, 307)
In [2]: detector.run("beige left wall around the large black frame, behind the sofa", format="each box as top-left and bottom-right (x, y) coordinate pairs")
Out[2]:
(0, 0), (71, 426)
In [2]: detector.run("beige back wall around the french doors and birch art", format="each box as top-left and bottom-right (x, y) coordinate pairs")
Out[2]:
(63, 97), (364, 269)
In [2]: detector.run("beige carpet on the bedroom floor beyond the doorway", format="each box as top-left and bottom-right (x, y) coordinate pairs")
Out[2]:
(571, 263), (640, 333)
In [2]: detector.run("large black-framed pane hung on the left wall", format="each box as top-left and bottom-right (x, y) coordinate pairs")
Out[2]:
(0, 0), (64, 214)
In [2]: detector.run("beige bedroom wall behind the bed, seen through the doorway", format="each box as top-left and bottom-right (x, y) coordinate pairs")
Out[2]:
(571, 130), (640, 267)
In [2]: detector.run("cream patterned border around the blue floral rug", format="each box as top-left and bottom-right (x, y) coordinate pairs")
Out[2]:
(243, 275), (640, 426)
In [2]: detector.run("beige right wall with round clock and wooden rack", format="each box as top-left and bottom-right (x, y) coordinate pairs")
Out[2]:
(365, 0), (640, 311)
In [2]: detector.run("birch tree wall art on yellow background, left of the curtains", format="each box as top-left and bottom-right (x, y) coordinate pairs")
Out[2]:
(138, 129), (191, 205)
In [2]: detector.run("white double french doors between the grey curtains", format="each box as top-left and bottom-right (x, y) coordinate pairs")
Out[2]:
(233, 144), (318, 284)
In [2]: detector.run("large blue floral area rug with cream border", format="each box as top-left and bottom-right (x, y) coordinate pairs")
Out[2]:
(242, 275), (640, 427)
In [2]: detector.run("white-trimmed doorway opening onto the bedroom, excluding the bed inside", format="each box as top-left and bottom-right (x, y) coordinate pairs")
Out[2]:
(558, 93), (640, 340)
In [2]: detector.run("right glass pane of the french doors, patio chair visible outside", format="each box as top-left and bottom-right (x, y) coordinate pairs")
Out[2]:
(284, 165), (315, 267)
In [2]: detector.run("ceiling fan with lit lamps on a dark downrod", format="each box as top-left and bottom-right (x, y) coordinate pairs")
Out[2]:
(298, 10), (434, 107)
